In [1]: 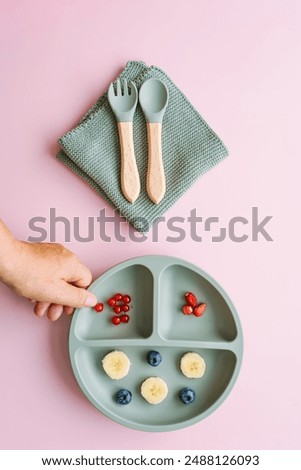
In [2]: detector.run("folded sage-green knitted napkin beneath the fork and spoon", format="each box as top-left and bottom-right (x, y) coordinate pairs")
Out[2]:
(58, 62), (227, 232)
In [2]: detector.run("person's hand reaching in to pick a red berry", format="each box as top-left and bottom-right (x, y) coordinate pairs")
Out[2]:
(0, 220), (97, 321)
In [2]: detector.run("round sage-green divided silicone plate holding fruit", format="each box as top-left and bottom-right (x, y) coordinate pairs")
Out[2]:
(69, 256), (243, 431)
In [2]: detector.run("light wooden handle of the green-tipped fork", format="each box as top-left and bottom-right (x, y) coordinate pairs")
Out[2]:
(118, 122), (140, 203)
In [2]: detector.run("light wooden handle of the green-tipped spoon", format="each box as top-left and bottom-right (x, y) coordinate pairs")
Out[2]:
(147, 122), (165, 204)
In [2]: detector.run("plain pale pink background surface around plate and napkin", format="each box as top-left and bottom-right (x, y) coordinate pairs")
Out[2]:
(0, 0), (301, 449)
